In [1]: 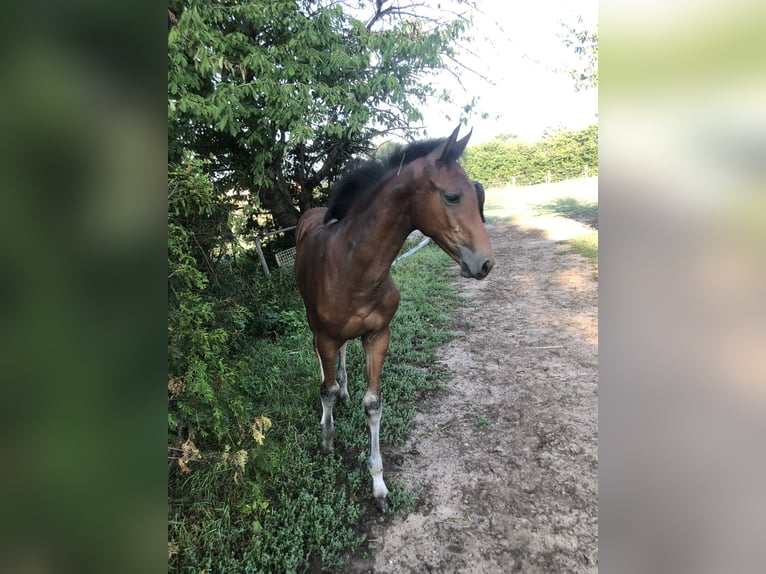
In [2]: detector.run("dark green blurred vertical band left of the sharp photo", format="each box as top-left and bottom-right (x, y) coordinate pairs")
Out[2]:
(0, 0), (167, 572)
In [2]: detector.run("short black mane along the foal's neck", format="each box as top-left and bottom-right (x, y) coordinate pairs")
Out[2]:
(324, 138), (459, 223)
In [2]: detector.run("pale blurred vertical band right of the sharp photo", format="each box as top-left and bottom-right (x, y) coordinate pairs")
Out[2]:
(599, 1), (766, 572)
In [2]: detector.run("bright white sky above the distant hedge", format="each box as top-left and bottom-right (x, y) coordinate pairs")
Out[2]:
(423, 0), (598, 144)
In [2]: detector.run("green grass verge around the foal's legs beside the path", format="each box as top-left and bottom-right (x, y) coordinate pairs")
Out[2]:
(168, 242), (457, 572)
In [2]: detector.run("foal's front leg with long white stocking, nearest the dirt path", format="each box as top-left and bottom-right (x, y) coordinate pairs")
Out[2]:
(362, 327), (391, 512)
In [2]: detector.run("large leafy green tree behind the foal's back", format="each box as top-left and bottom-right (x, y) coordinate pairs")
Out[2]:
(168, 0), (468, 227)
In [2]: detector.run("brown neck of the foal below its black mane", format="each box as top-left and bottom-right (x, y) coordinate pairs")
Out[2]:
(345, 174), (414, 274)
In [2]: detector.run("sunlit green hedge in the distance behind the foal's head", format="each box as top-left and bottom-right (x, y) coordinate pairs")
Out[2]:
(462, 124), (598, 185)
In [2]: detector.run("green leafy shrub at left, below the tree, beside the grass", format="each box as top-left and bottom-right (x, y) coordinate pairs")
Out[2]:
(168, 158), (251, 446)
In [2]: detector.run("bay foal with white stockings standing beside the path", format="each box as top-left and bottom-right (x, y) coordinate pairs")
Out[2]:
(295, 126), (495, 512)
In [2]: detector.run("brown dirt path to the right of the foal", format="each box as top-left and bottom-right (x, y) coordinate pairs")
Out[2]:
(343, 182), (598, 574)
